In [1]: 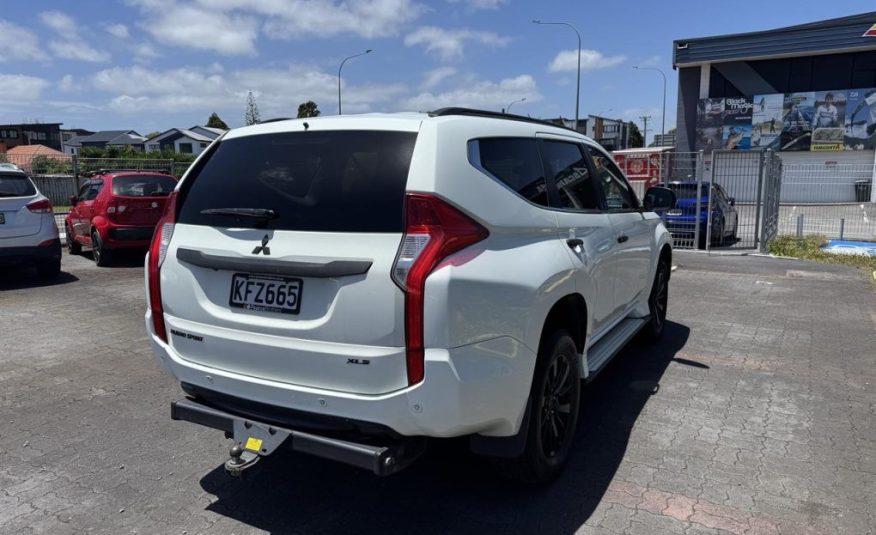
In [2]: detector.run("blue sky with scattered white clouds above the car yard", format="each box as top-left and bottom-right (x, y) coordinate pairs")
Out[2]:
(0, 0), (876, 139)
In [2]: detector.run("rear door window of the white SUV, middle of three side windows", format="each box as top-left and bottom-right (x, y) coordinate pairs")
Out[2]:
(542, 141), (599, 210)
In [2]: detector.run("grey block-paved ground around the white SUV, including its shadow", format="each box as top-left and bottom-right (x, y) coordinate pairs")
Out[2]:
(0, 253), (876, 535)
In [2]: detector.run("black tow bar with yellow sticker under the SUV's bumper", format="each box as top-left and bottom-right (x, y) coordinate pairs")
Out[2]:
(171, 399), (426, 477)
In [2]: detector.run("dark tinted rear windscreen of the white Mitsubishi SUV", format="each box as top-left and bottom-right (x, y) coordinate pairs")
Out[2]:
(178, 130), (417, 232)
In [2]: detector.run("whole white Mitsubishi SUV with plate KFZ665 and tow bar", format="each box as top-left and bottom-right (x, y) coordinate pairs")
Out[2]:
(146, 108), (674, 481)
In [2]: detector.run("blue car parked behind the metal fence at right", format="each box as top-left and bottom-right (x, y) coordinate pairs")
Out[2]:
(660, 180), (739, 249)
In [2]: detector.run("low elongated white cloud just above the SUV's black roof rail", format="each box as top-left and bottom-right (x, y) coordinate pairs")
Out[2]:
(402, 74), (541, 111)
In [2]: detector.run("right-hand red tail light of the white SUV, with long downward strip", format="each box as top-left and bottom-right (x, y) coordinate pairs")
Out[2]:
(392, 193), (490, 385)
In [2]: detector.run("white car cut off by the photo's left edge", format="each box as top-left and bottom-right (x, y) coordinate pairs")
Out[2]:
(0, 163), (61, 278)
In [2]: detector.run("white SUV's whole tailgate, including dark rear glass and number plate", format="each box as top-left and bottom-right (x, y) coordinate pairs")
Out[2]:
(161, 125), (416, 394)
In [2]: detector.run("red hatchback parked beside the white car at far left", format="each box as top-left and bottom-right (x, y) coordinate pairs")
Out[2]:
(64, 171), (176, 266)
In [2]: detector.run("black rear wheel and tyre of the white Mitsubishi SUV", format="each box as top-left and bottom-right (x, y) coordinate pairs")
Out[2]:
(494, 331), (581, 484)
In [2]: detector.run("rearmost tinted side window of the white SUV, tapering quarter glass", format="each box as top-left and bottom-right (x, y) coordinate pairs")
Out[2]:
(472, 138), (548, 206)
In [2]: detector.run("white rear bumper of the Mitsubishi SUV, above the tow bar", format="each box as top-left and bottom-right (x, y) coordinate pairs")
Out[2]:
(145, 311), (535, 437)
